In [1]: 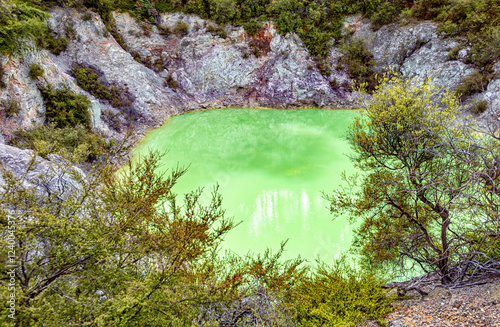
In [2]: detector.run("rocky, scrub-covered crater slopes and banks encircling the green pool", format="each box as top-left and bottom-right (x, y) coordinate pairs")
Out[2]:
(0, 0), (500, 326)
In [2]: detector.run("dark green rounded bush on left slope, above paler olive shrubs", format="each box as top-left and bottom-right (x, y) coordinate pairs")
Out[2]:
(40, 84), (91, 128)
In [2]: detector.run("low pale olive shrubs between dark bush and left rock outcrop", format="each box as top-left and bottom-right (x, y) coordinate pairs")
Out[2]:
(10, 124), (113, 163)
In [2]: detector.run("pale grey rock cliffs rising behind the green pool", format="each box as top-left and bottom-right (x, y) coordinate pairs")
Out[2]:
(0, 8), (500, 143)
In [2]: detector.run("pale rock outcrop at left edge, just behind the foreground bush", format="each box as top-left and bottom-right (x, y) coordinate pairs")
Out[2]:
(0, 144), (85, 197)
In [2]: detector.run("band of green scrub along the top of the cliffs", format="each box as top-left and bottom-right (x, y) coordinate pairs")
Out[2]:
(0, 0), (500, 93)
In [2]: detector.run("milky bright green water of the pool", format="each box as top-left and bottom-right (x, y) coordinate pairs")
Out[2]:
(135, 109), (356, 262)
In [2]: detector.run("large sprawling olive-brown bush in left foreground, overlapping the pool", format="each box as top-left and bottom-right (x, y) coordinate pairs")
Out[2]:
(0, 148), (310, 326)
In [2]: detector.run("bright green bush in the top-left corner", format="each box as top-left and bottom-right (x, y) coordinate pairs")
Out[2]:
(0, 0), (48, 54)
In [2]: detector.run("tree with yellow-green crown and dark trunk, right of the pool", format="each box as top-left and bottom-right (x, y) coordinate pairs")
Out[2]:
(327, 77), (499, 283)
